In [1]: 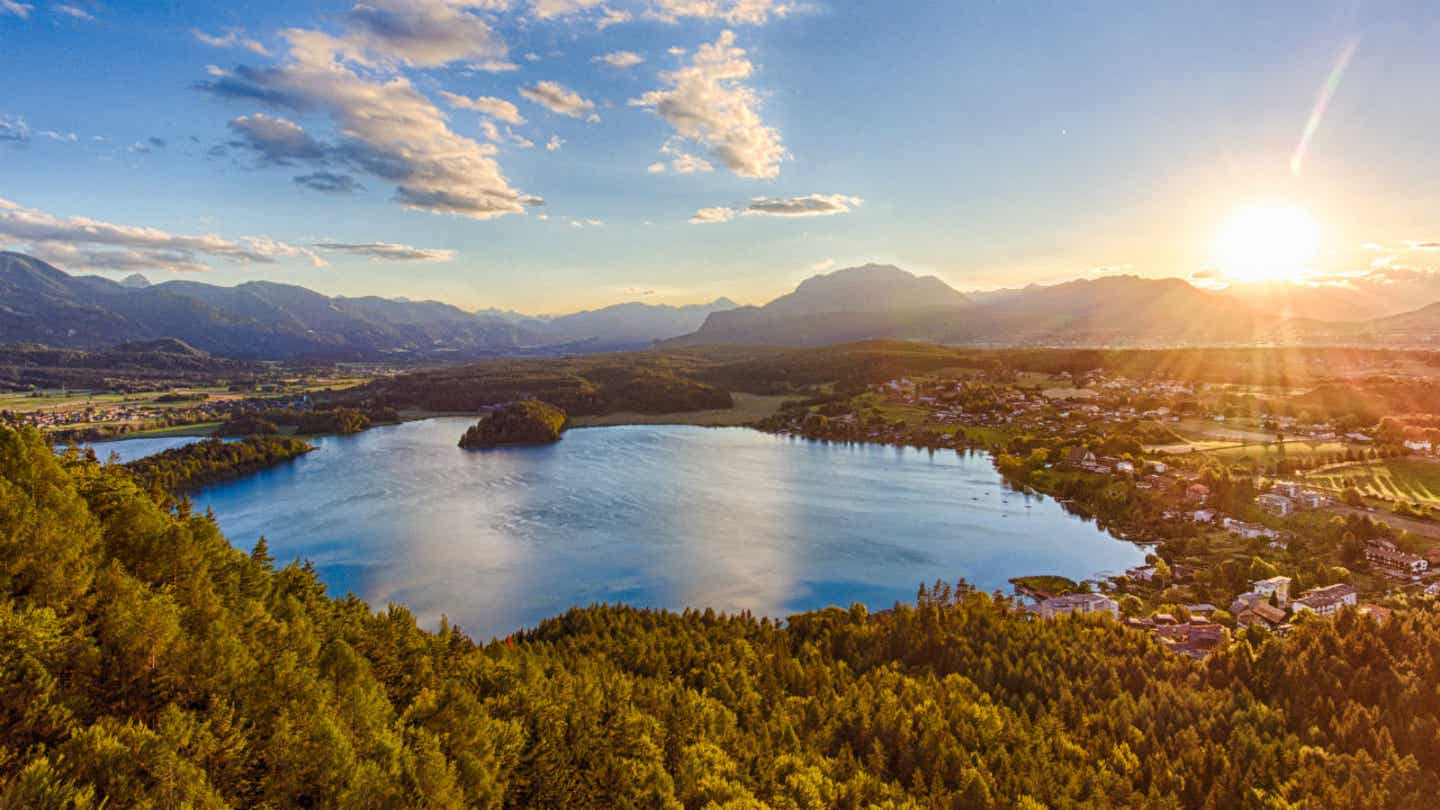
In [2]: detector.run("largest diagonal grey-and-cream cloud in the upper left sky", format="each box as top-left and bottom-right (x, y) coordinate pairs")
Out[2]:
(197, 24), (540, 219)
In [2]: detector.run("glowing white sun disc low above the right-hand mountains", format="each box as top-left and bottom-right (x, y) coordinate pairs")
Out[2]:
(1214, 205), (1320, 281)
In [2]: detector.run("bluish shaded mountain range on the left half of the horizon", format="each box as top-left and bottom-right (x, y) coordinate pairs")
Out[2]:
(0, 252), (734, 359)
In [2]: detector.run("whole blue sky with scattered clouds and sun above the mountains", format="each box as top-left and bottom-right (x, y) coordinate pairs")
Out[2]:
(0, 0), (1440, 313)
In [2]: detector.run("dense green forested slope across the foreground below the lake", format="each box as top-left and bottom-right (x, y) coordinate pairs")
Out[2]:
(0, 428), (1440, 809)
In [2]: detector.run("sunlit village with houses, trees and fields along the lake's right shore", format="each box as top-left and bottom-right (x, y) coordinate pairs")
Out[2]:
(766, 366), (1440, 657)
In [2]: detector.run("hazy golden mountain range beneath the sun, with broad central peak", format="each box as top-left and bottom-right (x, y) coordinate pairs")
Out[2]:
(662, 259), (1440, 347)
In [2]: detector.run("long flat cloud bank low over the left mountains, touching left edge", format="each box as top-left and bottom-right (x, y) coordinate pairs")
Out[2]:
(0, 199), (325, 271)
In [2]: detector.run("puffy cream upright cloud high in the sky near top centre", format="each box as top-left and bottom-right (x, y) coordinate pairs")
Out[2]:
(629, 30), (788, 177)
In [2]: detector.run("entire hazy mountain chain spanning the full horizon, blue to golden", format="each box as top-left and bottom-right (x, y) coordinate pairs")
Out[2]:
(0, 252), (1440, 359)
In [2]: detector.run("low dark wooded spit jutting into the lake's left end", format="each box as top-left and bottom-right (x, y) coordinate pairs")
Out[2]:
(125, 435), (315, 493)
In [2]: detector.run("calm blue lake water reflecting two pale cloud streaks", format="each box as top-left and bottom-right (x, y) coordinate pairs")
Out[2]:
(108, 418), (1143, 638)
